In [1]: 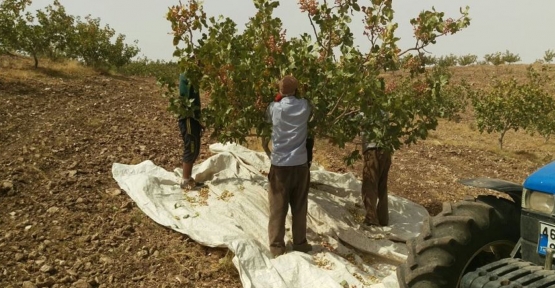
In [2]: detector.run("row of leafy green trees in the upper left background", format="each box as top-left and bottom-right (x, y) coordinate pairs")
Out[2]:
(0, 0), (139, 69)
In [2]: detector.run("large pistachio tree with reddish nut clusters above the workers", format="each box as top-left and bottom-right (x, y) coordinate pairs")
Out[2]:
(163, 0), (470, 160)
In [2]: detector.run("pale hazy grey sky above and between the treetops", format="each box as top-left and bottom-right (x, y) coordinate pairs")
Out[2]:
(31, 0), (555, 63)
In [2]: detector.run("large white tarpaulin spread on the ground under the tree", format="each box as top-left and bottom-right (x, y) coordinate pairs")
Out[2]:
(112, 144), (428, 288)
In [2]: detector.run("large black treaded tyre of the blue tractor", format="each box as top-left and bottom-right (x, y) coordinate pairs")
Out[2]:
(397, 195), (520, 288)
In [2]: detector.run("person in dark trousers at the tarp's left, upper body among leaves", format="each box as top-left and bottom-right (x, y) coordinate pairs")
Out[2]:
(178, 73), (203, 190)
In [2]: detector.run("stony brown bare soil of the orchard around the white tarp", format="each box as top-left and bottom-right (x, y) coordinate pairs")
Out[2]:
(0, 57), (555, 287)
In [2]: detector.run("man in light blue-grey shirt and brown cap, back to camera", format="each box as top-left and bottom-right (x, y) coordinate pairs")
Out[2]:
(267, 76), (312, 257)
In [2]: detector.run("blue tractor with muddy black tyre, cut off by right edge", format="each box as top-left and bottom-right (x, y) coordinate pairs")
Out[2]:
(397, 162), (555, 288)
